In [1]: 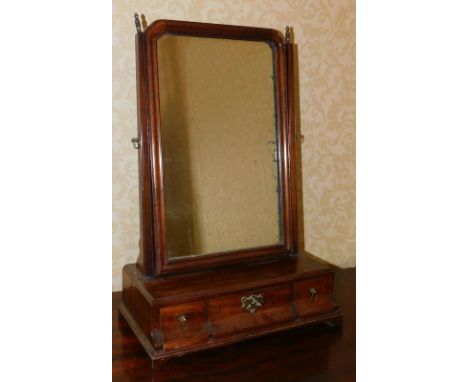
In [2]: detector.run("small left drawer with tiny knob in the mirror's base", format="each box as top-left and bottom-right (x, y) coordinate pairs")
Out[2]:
(159, 301), (208, 350)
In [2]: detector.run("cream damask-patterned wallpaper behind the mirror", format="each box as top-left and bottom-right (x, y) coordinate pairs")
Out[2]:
(112, 0), (356, 290)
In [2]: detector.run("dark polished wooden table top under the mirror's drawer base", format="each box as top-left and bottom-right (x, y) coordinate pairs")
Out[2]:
(112, 268), (356, 382)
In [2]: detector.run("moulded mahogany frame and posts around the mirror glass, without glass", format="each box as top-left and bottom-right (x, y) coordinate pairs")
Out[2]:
(134, 17), (298, 277)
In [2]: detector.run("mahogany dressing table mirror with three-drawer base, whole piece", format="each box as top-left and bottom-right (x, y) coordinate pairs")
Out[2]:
(120, 14), (341, 360)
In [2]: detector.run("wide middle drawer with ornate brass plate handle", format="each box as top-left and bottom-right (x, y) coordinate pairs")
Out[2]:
(209, 286), (295, 337)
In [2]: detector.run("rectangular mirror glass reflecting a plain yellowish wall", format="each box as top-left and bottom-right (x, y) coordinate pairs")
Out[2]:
(157, 34), (283, 258)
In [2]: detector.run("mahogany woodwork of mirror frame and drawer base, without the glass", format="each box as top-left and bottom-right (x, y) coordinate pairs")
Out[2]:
(121, 20), (341, 367)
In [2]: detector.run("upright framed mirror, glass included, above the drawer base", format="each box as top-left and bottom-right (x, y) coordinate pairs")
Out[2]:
(133, 20), (295, 276)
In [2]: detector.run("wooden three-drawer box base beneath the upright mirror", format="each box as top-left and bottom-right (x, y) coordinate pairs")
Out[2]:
(120, 254), (342, 360)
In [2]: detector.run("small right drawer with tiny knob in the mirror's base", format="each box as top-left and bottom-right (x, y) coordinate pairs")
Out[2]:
(294, 275), (335, 316)
